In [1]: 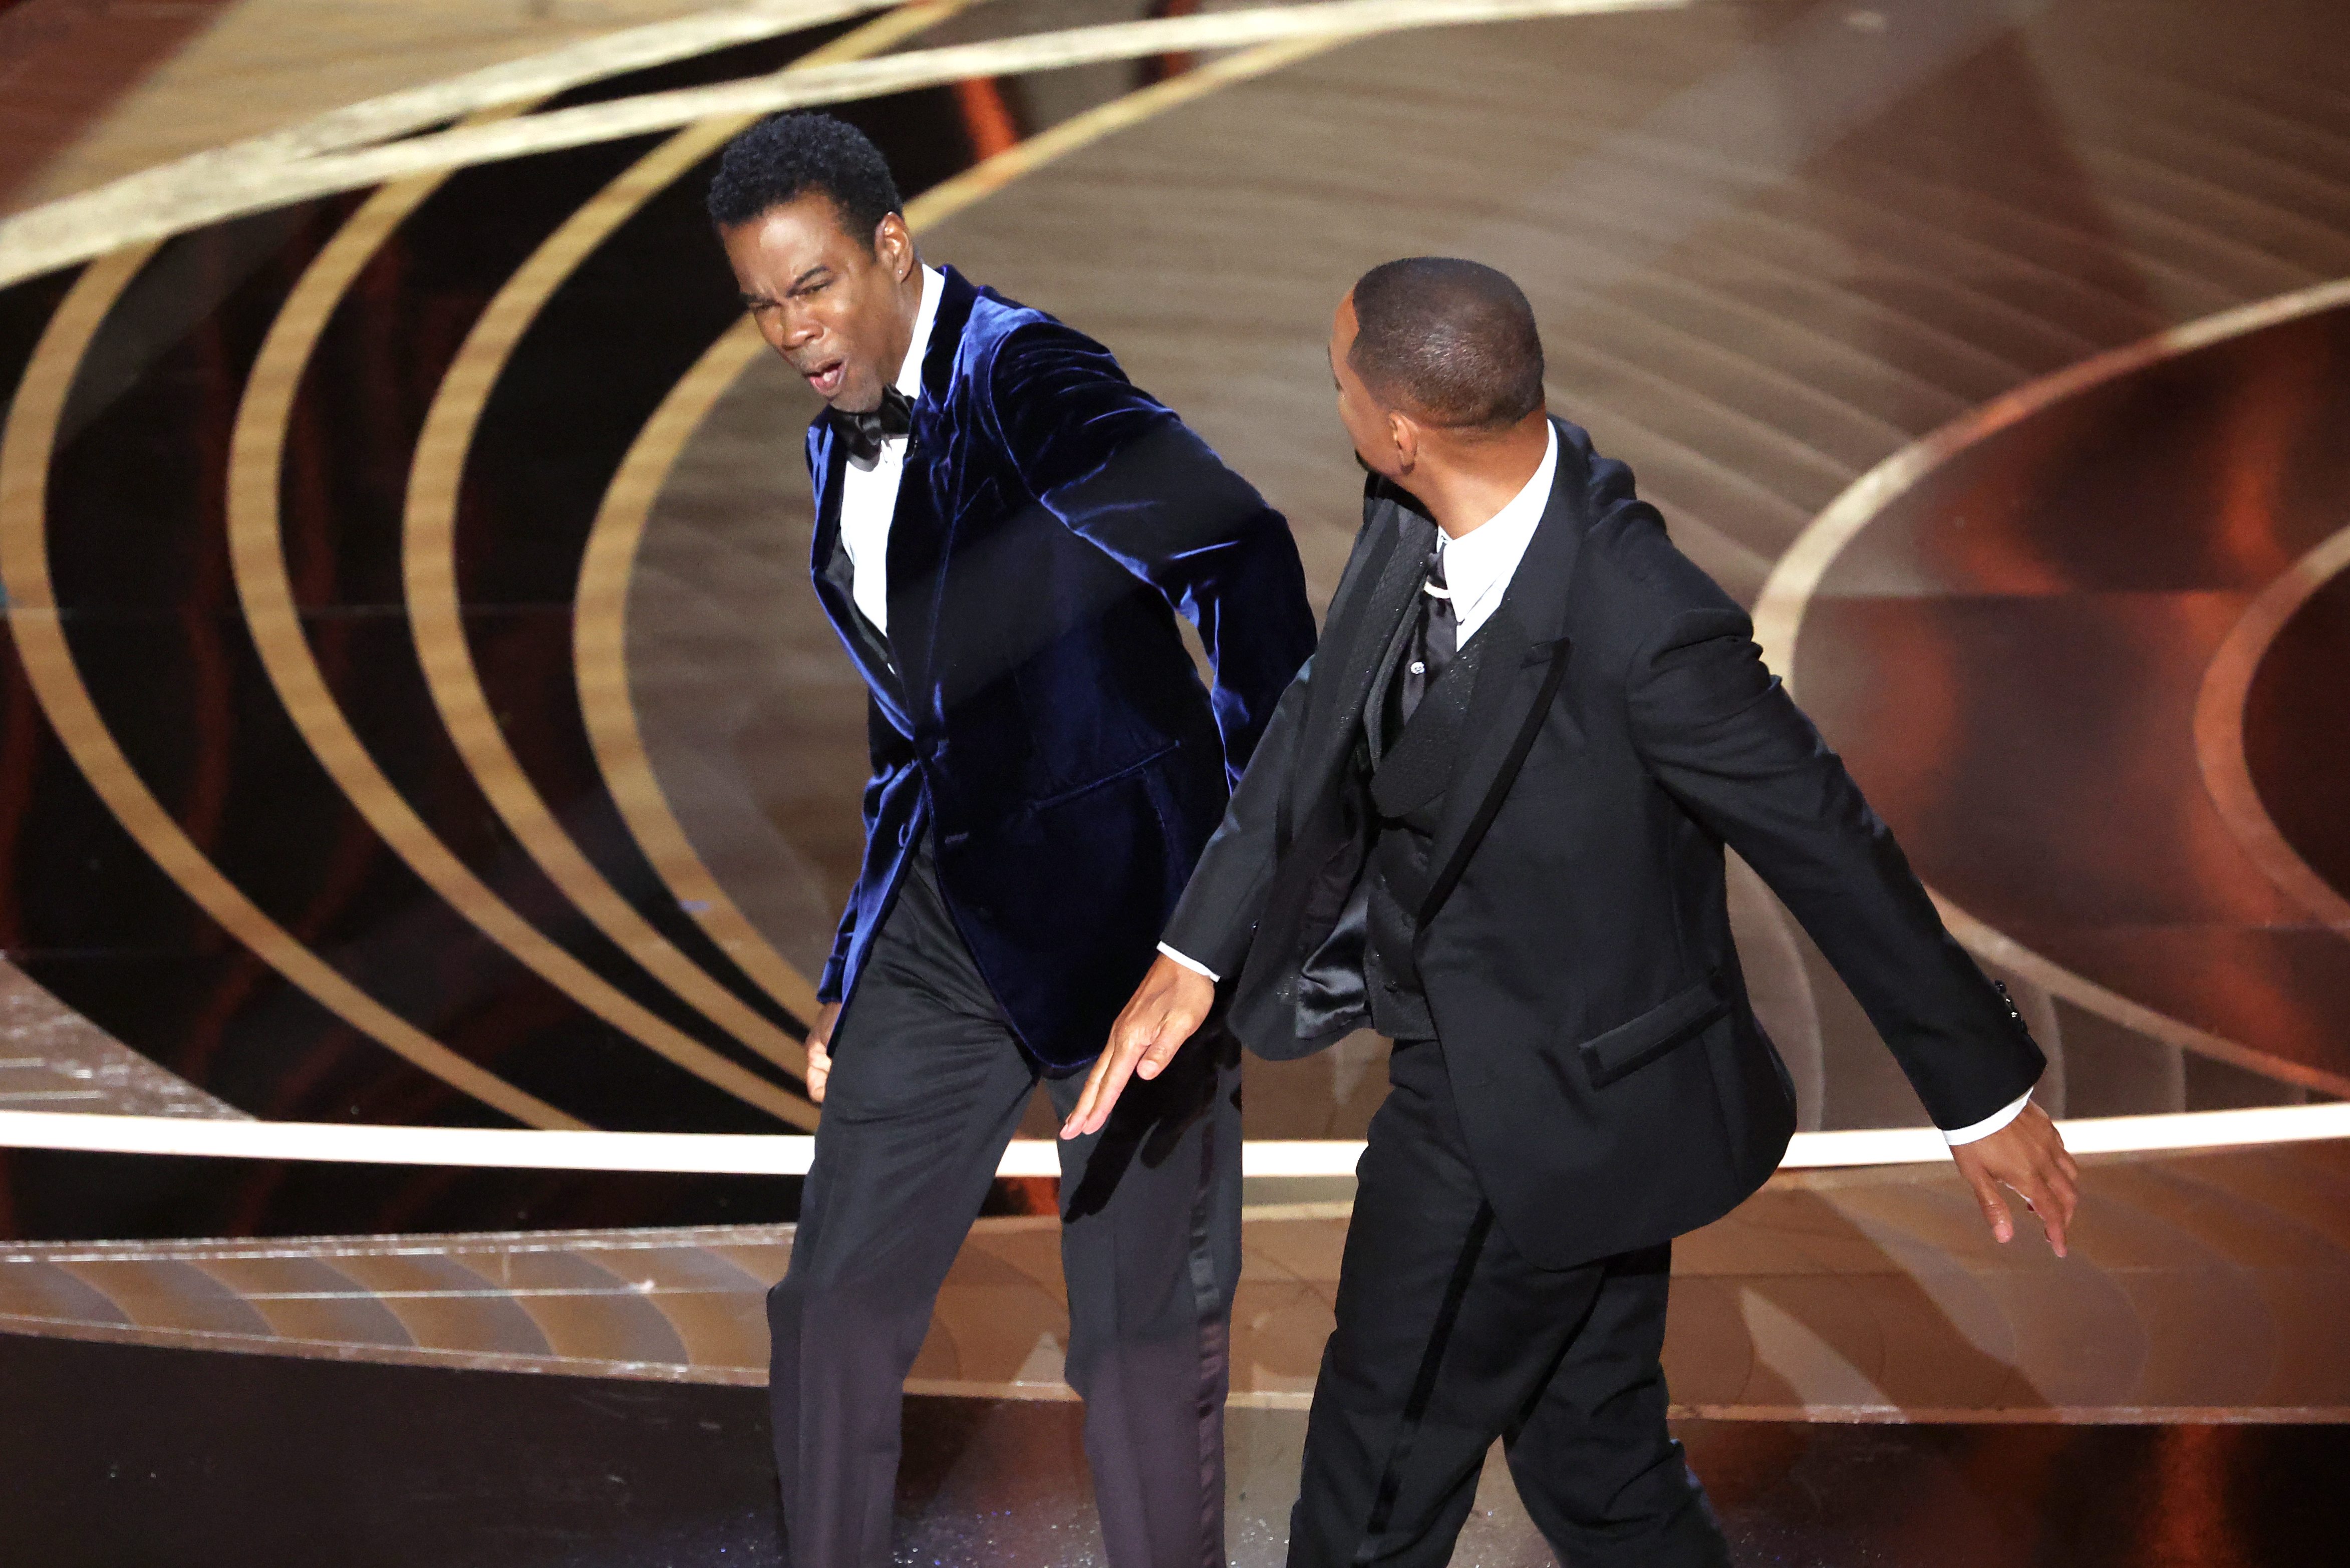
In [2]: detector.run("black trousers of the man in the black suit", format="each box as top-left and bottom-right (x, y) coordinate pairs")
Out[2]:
(1290, 1039), (1729, 1568)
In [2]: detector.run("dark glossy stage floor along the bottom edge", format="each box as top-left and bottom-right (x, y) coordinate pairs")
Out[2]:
(0, 1335), (2350, 1568)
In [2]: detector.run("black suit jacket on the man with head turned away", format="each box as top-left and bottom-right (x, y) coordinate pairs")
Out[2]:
(1168, 421), (2042, 1267)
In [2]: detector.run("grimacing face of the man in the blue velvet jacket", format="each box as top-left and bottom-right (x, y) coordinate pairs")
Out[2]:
(719, 190), (919, 414)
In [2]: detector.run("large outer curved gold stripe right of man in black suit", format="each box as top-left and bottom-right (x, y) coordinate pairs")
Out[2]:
(1753, 277), (2350, 1098)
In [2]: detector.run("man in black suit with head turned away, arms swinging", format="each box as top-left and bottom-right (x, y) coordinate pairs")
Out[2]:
(1064, 258), (2075, 1568)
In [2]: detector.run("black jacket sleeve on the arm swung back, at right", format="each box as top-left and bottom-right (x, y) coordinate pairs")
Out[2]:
(1626, 566), (2044, 1128)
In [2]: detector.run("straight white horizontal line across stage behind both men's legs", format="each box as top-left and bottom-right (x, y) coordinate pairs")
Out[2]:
(0, 1103), (2350, 1175)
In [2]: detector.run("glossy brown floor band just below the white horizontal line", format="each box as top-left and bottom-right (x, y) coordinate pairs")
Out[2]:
(0, 1145), (2350, 1422)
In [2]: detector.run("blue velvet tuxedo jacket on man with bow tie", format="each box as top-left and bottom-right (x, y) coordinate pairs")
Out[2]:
(808, 268), (1314, 1067)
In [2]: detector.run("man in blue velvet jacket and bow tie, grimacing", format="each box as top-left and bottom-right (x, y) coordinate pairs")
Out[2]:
(710, 115), (1314, 1568)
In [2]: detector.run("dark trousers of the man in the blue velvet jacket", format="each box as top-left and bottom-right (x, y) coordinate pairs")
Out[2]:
(768, 856), (1241, 1568)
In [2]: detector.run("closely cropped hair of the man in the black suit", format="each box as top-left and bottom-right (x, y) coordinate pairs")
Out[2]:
(1347, 256), (1542, 430)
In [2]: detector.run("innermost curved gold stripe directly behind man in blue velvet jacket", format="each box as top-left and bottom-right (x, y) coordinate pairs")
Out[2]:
(571, 38), (1342, 1018)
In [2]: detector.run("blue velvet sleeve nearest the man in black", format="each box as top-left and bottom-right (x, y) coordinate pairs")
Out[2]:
(989, 320), (1314, 788)
